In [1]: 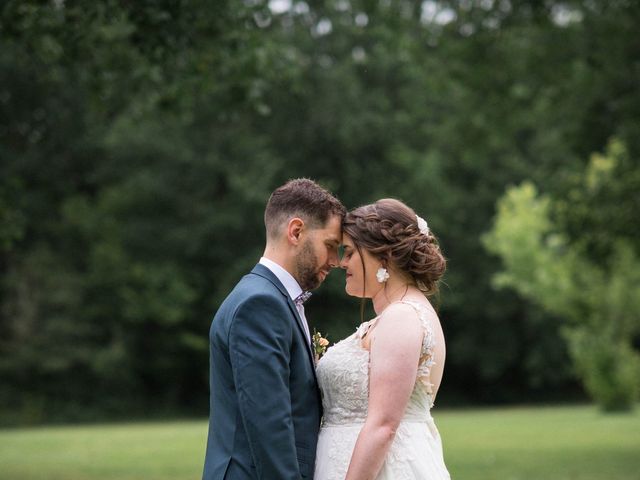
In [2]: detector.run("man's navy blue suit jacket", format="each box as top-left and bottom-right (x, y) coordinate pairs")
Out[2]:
(202, 264), (322, 480)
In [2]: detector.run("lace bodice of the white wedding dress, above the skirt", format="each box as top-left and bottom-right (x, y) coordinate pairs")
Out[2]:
(317, 301), (435, 425)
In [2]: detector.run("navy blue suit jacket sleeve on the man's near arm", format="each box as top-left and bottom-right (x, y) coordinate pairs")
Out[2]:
(229, 295), (300, 480)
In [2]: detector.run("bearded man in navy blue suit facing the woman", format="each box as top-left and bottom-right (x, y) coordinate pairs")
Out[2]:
(202, 179), (345, 480)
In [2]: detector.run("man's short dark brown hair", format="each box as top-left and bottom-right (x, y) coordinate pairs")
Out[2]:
(264, 178), (347, 238)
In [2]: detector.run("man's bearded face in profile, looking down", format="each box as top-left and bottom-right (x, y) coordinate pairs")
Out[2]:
(295, 216), (342, 290)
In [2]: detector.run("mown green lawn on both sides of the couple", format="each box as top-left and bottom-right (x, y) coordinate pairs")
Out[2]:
(0, 406), (640, 480)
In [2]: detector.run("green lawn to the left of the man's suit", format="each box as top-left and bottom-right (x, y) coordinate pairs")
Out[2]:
(0, 421), (207, 480)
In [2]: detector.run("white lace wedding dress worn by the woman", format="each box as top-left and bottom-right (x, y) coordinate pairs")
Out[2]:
(313, 302), (450, 480)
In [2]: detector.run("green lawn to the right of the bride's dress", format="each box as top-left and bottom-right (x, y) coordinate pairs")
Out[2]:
(434, 406), (640, 480)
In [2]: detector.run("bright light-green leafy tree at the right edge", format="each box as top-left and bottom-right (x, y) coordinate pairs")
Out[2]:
(484, 141), (640, 410)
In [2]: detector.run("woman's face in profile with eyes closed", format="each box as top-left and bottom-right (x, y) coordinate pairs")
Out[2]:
(340, 233), (384, 298)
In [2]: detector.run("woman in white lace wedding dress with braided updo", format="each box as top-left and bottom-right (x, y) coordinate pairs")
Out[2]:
(314, 199), (450, 480)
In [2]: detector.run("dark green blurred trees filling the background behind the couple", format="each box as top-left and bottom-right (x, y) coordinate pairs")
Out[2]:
(0, 0), (640, 422)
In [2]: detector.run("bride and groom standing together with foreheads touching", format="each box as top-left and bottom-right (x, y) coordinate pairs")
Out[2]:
(203, 179), (449, 480)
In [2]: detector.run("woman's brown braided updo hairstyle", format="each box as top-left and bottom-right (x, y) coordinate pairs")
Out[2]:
(342, 198), (447, 296)
